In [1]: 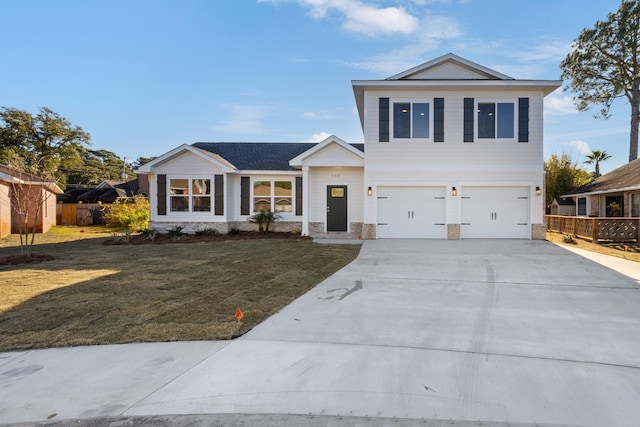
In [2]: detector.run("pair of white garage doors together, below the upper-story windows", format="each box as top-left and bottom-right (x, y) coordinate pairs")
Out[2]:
(376, 186), (531, 239)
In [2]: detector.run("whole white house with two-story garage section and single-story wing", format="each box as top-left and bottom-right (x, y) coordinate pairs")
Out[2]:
(137, 54), (560, 239)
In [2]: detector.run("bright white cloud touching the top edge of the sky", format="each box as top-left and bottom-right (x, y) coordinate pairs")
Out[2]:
(258, 0), (418, 36)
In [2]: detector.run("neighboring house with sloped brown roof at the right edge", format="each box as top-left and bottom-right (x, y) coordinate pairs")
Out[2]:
(563, 159), (640, 218)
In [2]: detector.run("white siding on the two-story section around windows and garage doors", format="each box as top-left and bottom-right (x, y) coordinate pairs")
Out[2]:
(364, 88), (543, 232)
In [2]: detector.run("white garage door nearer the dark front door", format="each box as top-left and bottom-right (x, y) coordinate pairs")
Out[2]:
(376, 187), (447, 239)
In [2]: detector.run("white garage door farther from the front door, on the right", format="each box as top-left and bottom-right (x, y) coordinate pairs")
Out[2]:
(460, 187), (531, 239)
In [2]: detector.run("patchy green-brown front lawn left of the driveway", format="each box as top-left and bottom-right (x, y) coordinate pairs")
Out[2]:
(0, 227), (359, 351)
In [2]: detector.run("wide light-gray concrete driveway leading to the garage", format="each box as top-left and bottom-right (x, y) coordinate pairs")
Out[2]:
(0, 240), (640, 426)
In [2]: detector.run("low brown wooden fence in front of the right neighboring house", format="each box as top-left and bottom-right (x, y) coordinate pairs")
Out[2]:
(545, 215), (640, 243)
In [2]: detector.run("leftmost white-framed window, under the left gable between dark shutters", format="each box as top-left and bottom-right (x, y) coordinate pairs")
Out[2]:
(169, 178), (211, 212)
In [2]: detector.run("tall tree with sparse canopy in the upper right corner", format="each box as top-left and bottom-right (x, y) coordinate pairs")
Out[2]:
(560, 0), (640, 161)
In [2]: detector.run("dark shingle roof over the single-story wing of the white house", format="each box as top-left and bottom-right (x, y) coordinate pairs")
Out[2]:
(193, 142), (364, 170)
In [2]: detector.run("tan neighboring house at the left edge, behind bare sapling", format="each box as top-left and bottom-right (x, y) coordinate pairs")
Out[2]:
(0, 165), (62, 238)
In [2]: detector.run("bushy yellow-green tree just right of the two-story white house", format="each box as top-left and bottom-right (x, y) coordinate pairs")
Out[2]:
(544, 153), (592, 208)
